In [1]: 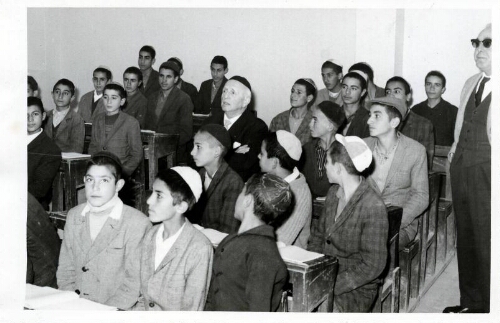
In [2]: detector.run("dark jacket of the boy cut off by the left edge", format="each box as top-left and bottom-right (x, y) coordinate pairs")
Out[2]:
(28, 131), (62, 209)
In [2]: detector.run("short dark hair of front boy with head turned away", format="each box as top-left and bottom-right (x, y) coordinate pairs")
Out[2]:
(243, 173), (293, 225)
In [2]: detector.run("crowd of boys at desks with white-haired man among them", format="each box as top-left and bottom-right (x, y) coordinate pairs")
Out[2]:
(27, 22), (490, 312)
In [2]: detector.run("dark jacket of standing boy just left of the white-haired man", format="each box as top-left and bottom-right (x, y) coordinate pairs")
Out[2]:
(144, 86), (193, 145)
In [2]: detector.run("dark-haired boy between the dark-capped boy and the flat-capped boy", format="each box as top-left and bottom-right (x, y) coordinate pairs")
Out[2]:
(339, 71), (370, 138)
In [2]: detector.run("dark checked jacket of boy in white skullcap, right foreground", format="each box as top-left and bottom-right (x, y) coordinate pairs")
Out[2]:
(308, 179), (389, 312)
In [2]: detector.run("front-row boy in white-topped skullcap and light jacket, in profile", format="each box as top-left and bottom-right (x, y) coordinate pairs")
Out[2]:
(134, 167), (213, 311)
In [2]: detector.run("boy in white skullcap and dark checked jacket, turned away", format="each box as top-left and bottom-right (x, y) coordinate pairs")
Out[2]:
(309, 134), (389, 312)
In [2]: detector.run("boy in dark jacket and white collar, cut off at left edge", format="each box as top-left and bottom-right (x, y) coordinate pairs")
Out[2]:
(28, 96), (61, 210)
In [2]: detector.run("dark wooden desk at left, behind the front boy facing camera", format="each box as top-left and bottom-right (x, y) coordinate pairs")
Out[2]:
(52, 155), (90, 212)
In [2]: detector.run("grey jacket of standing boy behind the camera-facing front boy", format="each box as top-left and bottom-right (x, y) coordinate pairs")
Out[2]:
(89, 111), (143, 176)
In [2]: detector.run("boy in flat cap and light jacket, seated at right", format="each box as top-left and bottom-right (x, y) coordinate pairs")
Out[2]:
(365, 97), (429, 250)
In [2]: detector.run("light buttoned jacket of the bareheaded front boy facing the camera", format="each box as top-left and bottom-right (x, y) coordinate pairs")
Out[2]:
(57, 204), (151, 309)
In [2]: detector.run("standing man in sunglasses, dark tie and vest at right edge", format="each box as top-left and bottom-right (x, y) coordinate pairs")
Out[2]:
(443, 24), (492, 313)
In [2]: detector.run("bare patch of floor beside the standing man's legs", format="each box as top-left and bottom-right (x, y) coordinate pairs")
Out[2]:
(413, 255), (460, 313)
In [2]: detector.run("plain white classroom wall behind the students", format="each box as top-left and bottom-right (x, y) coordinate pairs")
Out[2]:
(28, 8), (490, 124)
